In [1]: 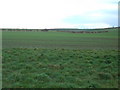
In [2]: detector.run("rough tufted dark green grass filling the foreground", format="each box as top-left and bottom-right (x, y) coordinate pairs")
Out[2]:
(2, 48), (118, 88)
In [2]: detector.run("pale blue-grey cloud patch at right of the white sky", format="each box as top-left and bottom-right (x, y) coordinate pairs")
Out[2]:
(64, 10), (118, 26)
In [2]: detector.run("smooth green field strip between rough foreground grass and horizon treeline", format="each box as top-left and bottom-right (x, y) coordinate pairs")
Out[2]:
(2, 30), (118, 49)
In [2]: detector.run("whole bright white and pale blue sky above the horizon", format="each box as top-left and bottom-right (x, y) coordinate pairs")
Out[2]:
(0, 0), (119, 29)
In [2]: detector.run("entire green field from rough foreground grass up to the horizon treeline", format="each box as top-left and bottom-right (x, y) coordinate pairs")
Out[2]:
(2, 29), (120, 88)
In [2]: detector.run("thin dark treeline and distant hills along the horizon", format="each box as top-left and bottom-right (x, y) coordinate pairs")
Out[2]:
(0, 27), (120, 31)
